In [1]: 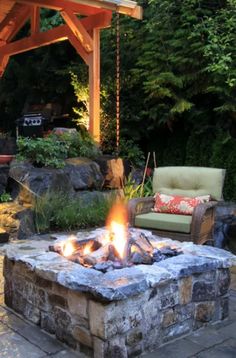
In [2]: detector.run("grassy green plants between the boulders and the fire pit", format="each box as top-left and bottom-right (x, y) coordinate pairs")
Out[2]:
(34, 193), (113, 233)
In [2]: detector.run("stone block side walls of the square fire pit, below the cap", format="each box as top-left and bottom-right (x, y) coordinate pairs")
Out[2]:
(4, 258), (230, 358)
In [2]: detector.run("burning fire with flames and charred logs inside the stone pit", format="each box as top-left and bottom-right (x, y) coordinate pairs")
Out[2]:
(52, 202), (182, 273)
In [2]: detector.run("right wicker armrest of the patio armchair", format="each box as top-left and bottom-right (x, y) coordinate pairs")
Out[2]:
(191, 201), (218, 244)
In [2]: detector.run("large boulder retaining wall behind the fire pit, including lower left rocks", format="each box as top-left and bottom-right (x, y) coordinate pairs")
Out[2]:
(0, 156), (128, 239)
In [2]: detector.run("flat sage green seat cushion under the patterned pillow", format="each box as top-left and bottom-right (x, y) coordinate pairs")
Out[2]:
(135, 212), (192, 233)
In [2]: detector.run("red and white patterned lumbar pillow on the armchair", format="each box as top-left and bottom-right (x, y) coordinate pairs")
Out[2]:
(153, 193), (210, 215)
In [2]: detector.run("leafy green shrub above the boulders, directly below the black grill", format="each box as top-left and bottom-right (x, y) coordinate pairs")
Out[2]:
(16, 136), (68, 168)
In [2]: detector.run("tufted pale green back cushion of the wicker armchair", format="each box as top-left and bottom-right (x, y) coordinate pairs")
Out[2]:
(153, 167), (225, 200)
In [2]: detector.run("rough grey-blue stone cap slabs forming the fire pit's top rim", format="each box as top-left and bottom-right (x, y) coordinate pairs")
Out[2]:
(5, 229), (236, 301)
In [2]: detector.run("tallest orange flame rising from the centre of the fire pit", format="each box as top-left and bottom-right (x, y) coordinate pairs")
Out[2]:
(106, 202), (128, 258)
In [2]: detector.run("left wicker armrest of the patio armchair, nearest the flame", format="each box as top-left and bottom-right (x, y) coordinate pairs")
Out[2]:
(127, 196), (154, 226)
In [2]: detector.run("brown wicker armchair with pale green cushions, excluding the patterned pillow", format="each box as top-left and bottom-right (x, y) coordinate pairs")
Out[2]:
(128, 167), (225, 244)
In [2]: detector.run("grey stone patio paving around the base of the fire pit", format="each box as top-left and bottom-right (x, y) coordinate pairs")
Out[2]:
(0, 248), (236, 358)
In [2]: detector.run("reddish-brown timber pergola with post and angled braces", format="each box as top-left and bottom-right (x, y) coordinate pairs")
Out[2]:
(0, 0), (142, 142)
